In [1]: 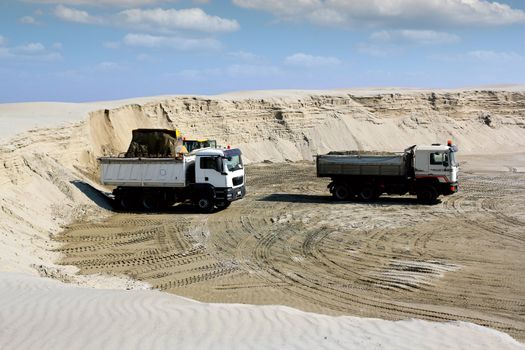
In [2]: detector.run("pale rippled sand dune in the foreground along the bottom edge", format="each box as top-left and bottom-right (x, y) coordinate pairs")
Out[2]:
(0, 273), (524, 350)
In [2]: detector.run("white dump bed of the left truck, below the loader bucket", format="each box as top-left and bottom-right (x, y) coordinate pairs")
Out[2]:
(99, 156), (194, 187)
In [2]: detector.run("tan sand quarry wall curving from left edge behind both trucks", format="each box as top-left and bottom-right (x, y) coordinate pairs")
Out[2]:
(0, 91), (525, 281)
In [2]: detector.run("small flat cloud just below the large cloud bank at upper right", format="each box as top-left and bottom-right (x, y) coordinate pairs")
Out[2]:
(370, 29), (460, 45)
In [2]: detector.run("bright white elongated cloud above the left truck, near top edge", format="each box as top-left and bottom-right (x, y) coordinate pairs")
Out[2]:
(118, 8), (239, 32)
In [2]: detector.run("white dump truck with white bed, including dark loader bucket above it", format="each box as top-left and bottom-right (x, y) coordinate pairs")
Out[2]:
(99, 129), (246, 212)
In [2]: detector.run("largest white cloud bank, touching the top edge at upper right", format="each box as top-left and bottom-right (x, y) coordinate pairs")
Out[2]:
(233, 0), (525, 28)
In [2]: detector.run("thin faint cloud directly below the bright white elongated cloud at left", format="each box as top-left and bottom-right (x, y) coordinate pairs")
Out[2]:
(124, 34), (221, 51)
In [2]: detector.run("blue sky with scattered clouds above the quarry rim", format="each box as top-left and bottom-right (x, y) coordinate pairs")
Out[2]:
(0, 0), (525, 103)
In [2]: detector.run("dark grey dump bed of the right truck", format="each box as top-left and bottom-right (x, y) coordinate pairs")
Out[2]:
(317, 152), (406, 177)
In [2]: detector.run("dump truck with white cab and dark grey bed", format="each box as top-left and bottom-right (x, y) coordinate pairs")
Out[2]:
(317, 141), (458, 203)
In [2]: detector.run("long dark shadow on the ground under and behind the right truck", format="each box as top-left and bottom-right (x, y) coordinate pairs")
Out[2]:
(258, 193), (441, 205)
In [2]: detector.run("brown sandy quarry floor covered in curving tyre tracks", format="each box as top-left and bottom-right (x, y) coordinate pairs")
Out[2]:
(55, 154), (525, 341)
